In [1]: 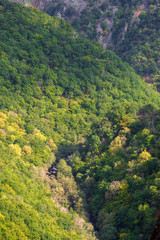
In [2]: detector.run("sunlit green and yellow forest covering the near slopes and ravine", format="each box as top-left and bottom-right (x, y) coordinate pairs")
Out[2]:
(0, 0), (160, 240)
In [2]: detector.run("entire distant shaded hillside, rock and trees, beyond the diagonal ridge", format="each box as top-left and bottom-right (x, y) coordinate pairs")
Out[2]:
(9, 0), (160, 91)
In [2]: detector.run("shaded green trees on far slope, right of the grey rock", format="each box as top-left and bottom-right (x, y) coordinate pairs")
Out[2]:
(113, 1), (160, 89)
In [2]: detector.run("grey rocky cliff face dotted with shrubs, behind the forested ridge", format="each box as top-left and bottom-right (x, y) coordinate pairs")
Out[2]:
(44, 0), (149, 49)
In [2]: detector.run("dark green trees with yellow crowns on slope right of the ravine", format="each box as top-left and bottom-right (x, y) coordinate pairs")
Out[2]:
(80, 105), (160, 240)
